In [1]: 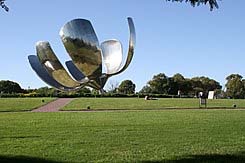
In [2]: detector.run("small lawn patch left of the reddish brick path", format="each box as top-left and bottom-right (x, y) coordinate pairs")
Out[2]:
(0, 98), (55, 112)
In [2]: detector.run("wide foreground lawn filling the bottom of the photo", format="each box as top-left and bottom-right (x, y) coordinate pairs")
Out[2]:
(0, 110), (245, 163)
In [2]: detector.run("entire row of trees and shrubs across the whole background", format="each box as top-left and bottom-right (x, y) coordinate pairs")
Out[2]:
(0, 73), (245, 99)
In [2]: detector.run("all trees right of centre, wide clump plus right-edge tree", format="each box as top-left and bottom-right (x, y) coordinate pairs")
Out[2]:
(139, 73), (245, 99)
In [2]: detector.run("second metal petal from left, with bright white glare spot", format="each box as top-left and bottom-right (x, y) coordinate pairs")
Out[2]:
(36, 41), (81, 88)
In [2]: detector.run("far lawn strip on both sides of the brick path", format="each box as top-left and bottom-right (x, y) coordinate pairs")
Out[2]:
(0, 98), (245, 112)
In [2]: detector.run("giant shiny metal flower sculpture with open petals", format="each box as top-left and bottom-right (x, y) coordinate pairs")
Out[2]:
(28, 18), (136, 92)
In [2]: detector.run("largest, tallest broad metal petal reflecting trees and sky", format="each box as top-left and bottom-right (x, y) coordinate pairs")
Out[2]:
(60, 19), (102, 79)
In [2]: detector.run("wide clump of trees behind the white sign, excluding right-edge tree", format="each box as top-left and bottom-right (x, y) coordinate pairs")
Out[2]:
(140, 73), (222, 97)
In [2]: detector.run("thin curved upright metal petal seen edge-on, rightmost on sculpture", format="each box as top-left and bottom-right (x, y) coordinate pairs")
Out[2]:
(108, 18), (136, 77)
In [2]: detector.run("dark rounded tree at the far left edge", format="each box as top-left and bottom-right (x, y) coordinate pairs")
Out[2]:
(0, 80), (23, 93)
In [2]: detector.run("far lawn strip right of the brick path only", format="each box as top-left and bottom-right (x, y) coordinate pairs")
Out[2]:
(62, 98), (245, 110)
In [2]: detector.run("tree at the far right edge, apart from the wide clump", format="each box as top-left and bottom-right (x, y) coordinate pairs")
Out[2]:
(225, 74), (245, 99)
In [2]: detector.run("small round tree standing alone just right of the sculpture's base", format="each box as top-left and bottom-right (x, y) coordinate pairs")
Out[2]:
(118, 80), (135, 94)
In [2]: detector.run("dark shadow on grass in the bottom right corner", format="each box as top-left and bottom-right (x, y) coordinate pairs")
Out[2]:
(142, 153), (245, 163)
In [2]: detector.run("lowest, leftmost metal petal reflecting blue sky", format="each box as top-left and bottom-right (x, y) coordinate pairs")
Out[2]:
(28, 55), (74, 91)
